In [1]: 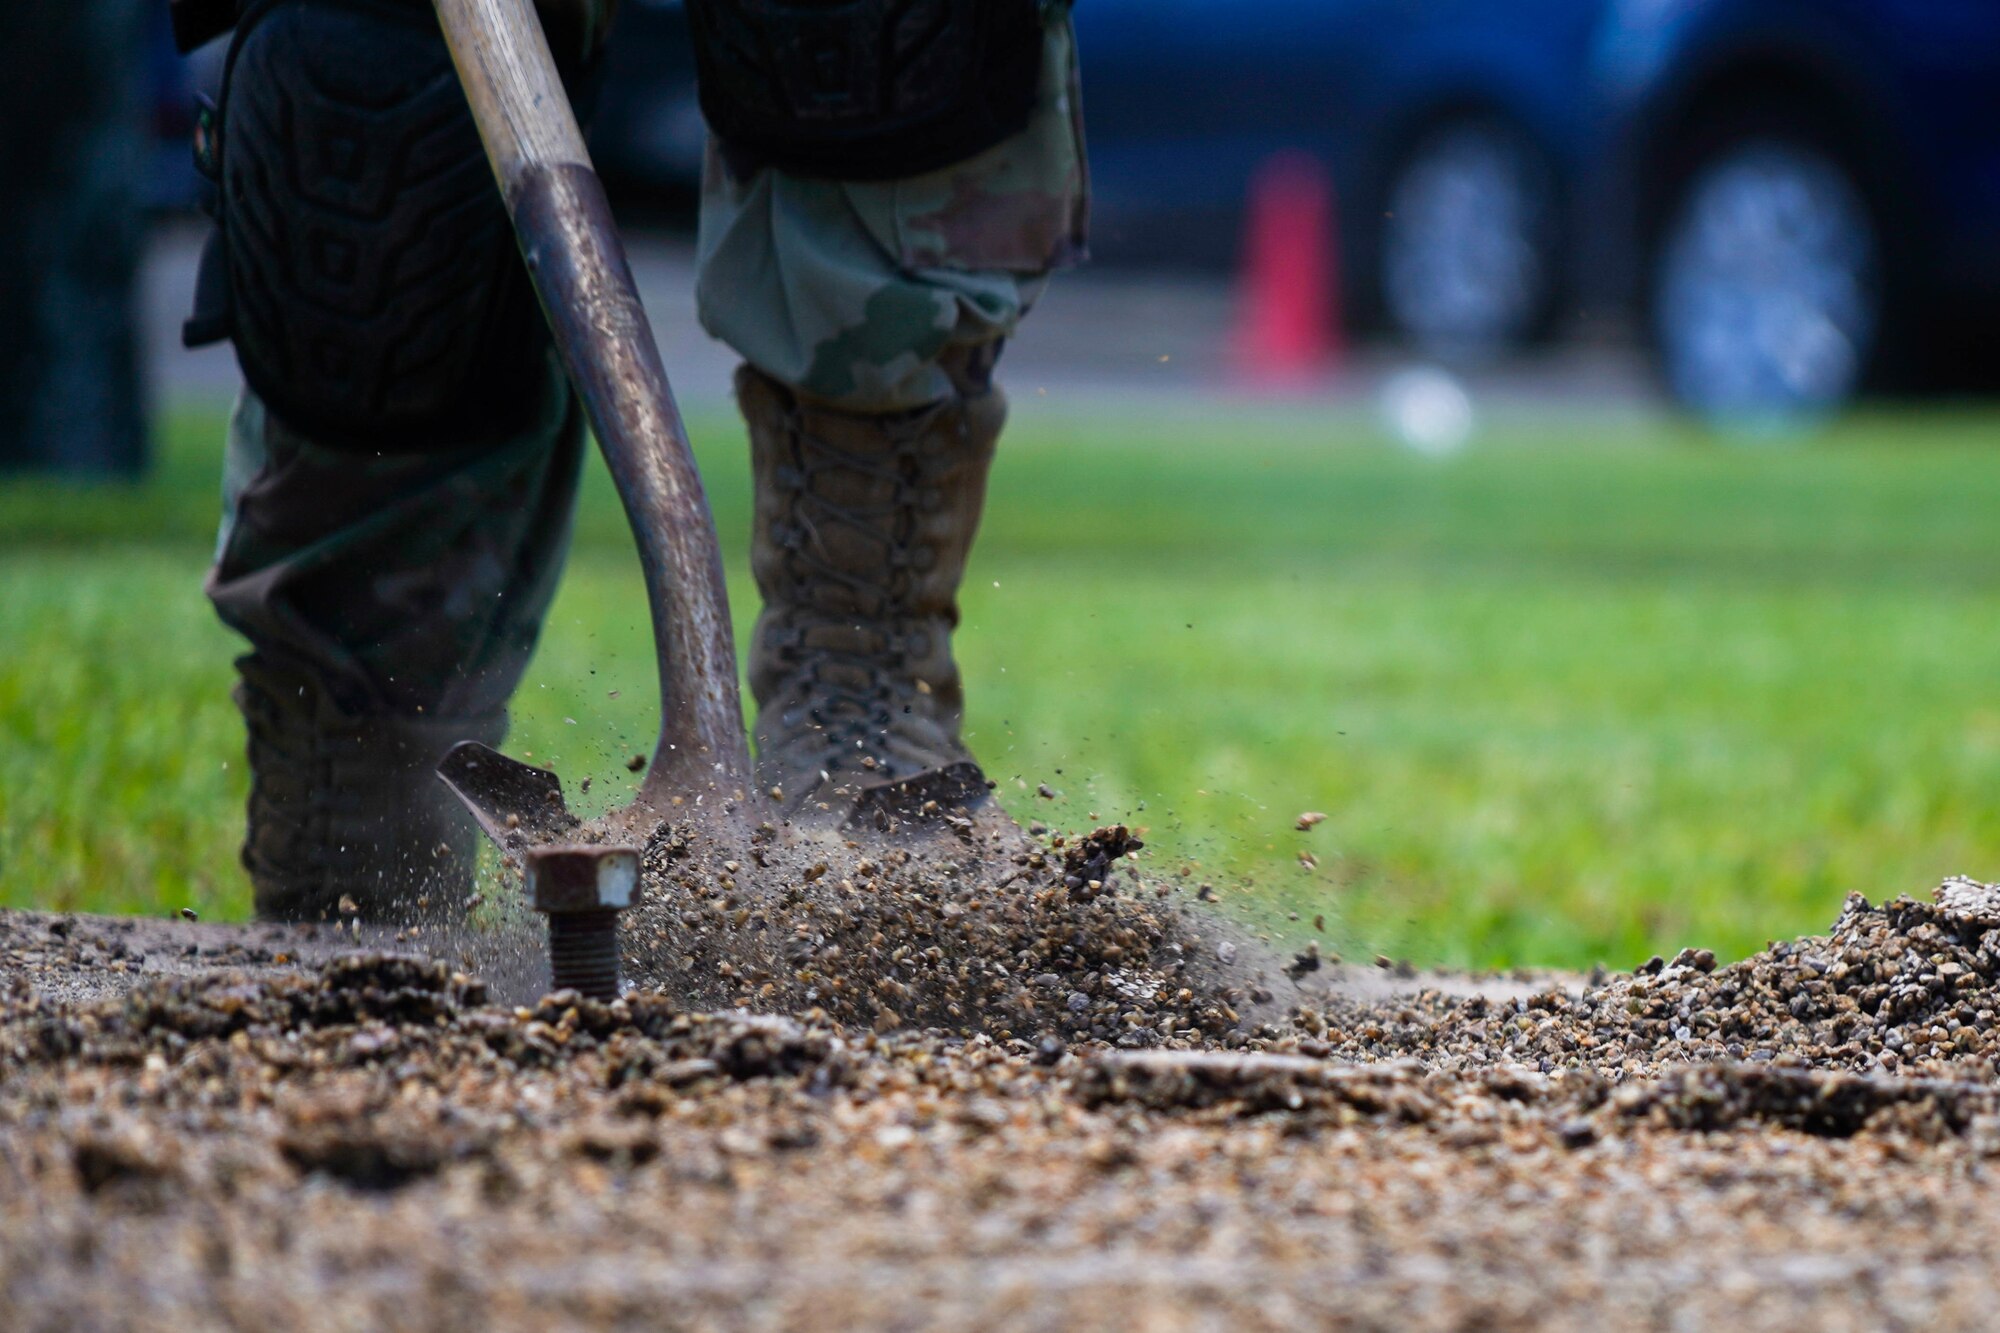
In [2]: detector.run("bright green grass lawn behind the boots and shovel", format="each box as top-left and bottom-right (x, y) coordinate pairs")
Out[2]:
(0, 398), (2000, 967)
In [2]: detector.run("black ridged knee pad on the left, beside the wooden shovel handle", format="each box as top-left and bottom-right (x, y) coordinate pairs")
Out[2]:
(188, 0), (564, 452)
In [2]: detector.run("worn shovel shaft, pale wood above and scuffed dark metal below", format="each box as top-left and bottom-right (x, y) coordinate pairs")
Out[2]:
(434, 0), (752, 807)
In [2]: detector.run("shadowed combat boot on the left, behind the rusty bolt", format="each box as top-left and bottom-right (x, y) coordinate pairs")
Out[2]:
(236, 652), (506, 923)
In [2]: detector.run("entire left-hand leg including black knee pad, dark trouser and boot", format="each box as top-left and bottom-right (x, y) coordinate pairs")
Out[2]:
(190, 0), (604, 921)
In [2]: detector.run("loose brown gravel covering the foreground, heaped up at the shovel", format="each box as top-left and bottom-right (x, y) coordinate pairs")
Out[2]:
(0, 844), (2000, 1329)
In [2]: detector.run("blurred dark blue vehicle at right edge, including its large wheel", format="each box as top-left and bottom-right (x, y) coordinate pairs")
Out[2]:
(1578, 0), (2000, 418)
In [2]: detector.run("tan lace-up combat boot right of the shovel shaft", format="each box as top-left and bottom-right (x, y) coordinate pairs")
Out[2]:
(736, 348), (1006, 823)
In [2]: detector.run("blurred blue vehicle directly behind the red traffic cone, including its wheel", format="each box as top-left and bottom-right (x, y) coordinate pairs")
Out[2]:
(1076, 0), (1604, 352)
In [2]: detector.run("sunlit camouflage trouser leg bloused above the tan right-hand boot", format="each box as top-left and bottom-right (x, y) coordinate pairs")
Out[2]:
(696, 4), (1088, 412)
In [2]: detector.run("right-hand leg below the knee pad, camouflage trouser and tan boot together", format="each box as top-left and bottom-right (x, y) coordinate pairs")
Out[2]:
(698, 0), (1088, 819)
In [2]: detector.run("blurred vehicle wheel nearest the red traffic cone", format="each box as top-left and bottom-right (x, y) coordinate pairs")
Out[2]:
(1376, 116), (1560, 360)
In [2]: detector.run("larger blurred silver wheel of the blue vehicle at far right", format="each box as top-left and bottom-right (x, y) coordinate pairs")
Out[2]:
(1646, 114), (1910, 424)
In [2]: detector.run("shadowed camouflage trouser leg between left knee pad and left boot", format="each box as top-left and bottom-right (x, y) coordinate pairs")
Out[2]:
(208, 362), (584, 717)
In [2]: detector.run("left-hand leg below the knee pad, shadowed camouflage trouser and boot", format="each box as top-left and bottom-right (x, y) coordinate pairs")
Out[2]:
(208, 374), (584, 921)
